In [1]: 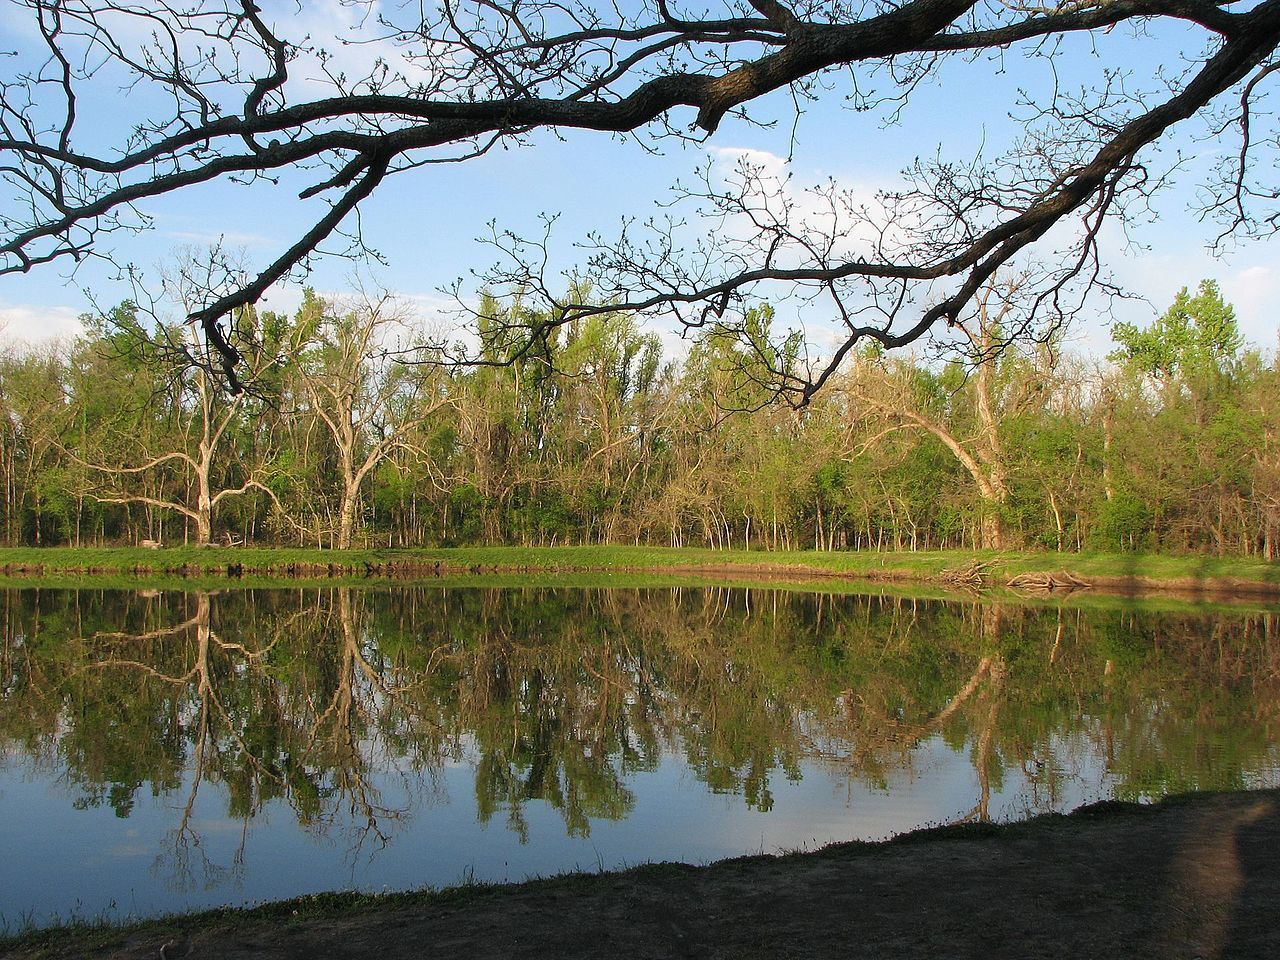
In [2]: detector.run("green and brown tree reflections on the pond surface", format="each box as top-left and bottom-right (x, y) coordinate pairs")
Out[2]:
(0, 586), (1280, 887)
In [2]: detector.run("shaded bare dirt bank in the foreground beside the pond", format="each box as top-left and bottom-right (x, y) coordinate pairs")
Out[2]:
(0, 790), (1280, 960)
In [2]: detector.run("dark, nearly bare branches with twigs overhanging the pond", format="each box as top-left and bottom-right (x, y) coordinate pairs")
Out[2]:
(0, 0), (1280, 402)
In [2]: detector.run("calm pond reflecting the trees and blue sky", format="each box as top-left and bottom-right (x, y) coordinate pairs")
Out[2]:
(0, 586), (1280, 928)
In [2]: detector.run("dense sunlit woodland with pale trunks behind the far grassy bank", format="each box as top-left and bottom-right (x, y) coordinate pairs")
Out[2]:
(0, 282), (1280, 559)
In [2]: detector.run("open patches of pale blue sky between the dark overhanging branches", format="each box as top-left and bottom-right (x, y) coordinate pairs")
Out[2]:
(0, 0), (1280, 352)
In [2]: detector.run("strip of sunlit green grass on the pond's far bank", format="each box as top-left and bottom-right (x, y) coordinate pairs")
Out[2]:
(0, 547), (1280, 596)
